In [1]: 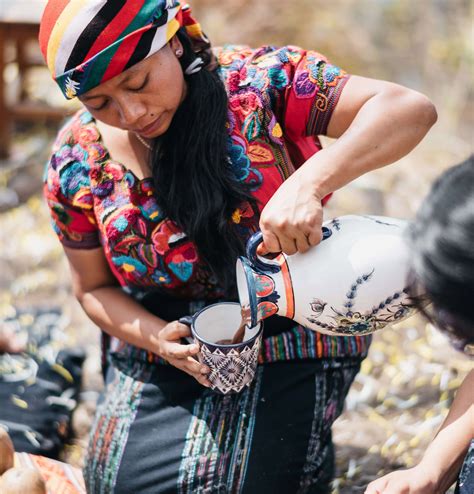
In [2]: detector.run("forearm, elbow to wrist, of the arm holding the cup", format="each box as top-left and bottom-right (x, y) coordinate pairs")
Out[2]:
(79, 286), (167, 354)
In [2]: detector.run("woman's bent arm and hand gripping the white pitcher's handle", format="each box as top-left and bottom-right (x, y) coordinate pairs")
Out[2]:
(260, 76), (437, 254)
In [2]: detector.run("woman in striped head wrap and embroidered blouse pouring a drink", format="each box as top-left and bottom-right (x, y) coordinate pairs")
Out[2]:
(40, 0), (436, 494)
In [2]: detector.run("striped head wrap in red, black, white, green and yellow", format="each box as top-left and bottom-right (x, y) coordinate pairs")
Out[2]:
(39, 0), (210, 99)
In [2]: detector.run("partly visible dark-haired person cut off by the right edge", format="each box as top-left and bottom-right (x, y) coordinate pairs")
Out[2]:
(365, 156), (474, 494)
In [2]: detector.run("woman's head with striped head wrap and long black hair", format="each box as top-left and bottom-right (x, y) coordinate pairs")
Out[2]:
(40, 0), (256, 294)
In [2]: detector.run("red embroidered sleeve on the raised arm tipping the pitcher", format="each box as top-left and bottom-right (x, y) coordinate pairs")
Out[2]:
(280, 47), (350, 138)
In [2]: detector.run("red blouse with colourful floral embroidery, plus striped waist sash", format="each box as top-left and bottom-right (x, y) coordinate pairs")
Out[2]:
(44, 46), (370, 361)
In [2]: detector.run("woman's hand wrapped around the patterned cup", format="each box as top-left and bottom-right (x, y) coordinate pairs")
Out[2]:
(157, 321), (211, 388)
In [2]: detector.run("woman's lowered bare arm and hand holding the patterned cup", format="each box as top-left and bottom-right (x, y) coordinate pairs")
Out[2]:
(64, 248), (209, 386)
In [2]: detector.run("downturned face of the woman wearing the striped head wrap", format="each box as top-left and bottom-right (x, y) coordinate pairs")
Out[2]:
(79, 36), (186, 139)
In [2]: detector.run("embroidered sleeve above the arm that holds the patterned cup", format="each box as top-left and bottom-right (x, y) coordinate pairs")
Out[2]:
(43, 123), (101, 249)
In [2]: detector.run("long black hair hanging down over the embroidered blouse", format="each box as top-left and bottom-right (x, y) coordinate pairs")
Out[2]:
(152, 29), (257, 295)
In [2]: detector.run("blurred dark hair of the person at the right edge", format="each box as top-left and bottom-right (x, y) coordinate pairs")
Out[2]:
(409, 155), (474, 345)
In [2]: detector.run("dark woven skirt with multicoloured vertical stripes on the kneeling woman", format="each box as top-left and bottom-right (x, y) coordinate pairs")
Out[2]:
(84, 355), (362, 494)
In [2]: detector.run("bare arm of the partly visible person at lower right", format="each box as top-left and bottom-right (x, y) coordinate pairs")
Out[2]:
(365, 371), (474, 494)
